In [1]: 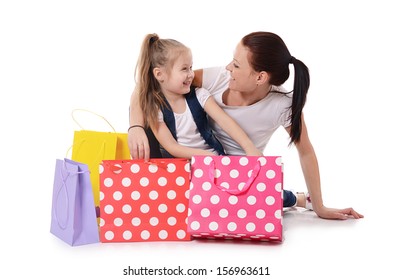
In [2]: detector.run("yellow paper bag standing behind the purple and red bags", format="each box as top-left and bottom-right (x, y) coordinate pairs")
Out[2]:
(72, 109), (130, 209)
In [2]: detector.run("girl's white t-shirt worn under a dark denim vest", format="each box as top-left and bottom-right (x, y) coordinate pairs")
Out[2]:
(158, 88), (214, 152)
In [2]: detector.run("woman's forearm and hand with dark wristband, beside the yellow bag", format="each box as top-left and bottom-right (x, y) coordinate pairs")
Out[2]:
(128, 88), (150, 161)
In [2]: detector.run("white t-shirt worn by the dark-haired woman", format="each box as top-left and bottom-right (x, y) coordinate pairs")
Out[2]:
(202, 67), (292, 155)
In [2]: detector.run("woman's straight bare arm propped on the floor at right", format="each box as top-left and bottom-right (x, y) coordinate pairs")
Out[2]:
(286, 116), (363, 220)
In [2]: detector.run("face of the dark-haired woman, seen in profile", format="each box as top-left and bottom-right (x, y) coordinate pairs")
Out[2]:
(226, 42), (258, 92)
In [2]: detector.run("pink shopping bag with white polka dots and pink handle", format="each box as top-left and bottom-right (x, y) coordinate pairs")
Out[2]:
(187, 156), (283, 241)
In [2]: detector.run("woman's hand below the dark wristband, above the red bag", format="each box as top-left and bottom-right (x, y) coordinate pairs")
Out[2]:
(128, 127), (150, 161)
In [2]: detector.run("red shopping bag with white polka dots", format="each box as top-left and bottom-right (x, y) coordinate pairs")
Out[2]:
(99, 158), (191, 242)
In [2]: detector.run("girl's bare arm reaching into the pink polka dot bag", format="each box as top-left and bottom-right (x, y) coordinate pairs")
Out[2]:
(204, 96), (262, 156)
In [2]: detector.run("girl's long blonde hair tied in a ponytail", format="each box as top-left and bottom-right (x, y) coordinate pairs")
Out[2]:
(135, 33), (189, 127)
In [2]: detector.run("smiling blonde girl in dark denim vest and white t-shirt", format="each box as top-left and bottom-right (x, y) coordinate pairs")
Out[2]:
(129, 34), (262, 158)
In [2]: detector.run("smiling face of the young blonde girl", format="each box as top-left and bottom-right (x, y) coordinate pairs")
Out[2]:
(161, 50), (194, 94)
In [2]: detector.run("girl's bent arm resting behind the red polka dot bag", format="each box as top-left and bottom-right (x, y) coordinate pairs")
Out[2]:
(152, 122), (214, 159)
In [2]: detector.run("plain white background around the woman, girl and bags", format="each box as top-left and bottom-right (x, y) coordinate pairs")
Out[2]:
(0, 0), (393, 279)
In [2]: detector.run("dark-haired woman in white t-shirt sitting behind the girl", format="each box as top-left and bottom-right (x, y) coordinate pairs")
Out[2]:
(129, 32), (363, 220)
